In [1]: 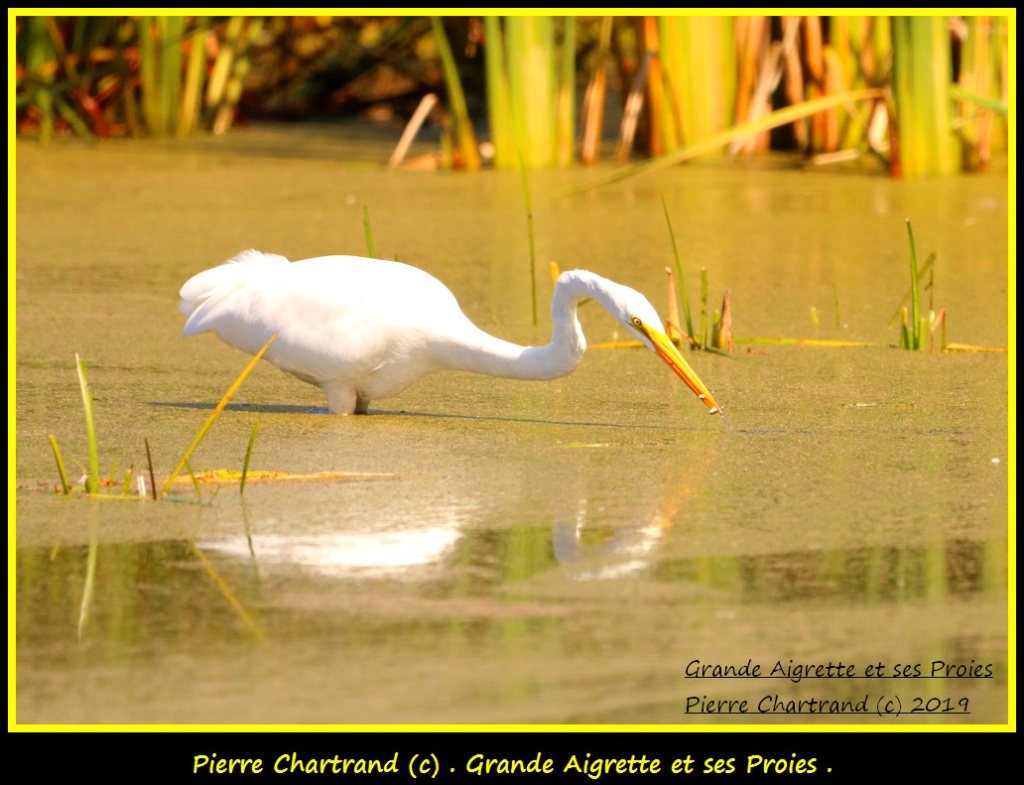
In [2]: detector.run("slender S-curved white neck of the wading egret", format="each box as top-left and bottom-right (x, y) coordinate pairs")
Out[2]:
(432, 270), (618, 380)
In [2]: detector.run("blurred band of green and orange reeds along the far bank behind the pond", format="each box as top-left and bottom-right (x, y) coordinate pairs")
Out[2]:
(15, 15), (1009, 177)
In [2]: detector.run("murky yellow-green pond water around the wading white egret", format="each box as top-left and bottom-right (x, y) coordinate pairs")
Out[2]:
(15, 129), (1009, 725)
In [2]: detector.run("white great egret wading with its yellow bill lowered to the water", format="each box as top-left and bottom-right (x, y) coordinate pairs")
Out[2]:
(179, 251), (721, 415)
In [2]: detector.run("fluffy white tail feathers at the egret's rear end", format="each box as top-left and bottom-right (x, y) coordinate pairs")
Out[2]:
(178, 250), (290, 337)
